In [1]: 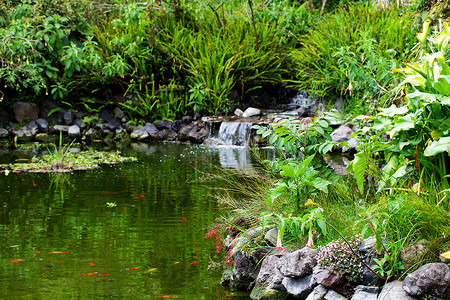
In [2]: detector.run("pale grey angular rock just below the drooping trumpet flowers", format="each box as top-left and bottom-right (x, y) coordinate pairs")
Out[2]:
(278, 247), (318, 277)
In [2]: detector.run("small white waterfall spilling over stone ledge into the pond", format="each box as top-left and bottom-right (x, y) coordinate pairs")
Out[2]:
(217, 122), (253, 146)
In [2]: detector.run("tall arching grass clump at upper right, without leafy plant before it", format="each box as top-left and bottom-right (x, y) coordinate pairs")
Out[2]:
(294, 2), (414, 106)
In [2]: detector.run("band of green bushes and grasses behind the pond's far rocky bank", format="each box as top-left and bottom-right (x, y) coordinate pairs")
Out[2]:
(0, 0), (448, 121)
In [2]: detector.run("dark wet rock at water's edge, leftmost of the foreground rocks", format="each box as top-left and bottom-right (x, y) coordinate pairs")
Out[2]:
(231, 251), (259, 291)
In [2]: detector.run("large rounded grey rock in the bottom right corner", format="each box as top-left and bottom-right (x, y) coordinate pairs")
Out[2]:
(403, 263), (450, 299)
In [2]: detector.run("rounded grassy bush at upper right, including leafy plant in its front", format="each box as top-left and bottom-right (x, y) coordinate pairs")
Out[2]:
(294, 3), (412, 108)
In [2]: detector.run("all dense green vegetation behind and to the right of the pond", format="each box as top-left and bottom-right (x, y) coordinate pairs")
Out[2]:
(0, 0), (450, 288)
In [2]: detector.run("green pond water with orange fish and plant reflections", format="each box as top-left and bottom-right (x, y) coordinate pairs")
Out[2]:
(0, 143), (260, 299)
